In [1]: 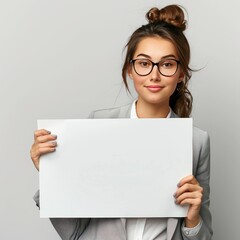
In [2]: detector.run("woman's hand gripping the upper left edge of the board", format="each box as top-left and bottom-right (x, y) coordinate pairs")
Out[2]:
(30, 129), (57, 170)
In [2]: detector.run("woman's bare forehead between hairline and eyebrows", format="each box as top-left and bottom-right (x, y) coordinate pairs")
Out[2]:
(134, 37), (178, 61)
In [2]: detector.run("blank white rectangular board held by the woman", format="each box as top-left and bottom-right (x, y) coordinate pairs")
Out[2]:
(38, 118), (192, 218)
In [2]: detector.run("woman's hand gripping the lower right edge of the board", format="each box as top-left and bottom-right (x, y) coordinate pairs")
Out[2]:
(174, 175), (203, 228)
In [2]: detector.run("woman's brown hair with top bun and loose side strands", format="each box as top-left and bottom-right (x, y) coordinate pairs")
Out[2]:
(122, 5), (193, 117)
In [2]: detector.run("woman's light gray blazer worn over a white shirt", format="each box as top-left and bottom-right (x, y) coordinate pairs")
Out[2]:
(34, 104), (212, 240)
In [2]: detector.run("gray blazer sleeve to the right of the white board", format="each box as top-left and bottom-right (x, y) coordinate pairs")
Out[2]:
(182, 129), (213, 240)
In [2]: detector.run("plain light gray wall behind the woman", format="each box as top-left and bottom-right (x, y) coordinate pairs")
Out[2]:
(0, 0), (240, 240)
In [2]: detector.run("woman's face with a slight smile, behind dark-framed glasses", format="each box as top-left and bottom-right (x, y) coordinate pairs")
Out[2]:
(128, 37), (184, 106)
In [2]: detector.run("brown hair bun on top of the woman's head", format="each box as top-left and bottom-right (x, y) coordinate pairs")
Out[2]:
(146, 5), (186, 31)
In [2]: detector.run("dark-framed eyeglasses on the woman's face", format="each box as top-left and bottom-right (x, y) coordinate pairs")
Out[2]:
(130, 58), (180, 77)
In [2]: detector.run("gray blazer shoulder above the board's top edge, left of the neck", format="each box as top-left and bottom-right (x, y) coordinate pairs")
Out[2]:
(89, 103), (132, 118)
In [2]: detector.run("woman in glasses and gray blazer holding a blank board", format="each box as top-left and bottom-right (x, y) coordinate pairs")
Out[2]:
(31, 5), (212, 240)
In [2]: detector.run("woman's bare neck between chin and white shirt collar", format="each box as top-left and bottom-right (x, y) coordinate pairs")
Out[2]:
(136, 99), (170, 118)
